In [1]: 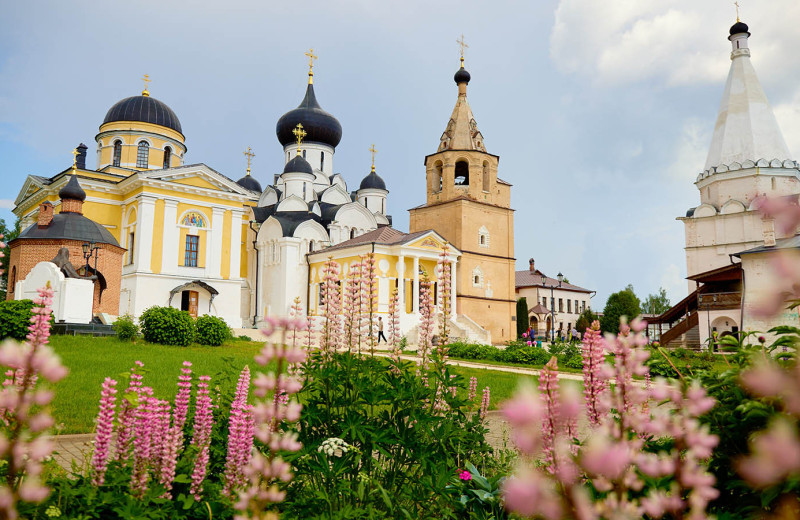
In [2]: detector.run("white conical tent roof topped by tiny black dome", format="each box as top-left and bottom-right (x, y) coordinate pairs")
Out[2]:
(705, 22), (791, 171)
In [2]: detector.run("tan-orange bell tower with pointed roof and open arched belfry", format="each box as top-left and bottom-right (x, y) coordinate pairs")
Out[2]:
(409, 43), (516, 344)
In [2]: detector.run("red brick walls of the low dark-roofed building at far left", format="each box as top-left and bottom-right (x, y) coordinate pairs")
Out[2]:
(6, 239), (125, 316)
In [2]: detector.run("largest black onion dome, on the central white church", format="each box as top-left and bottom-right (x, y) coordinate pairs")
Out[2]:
(275, 84), (342, 148)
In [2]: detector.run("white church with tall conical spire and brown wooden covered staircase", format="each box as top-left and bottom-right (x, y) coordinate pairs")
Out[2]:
(648, 20), (800, 348)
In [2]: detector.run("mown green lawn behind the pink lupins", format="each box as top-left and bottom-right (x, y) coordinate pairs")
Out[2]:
(50, 336), (536, 433)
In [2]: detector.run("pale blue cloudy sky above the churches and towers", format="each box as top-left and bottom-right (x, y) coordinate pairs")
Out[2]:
(0, 0), (800, 308)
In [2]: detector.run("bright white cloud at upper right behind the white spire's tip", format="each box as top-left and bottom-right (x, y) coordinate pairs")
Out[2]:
(550, 0), (800, 85)
